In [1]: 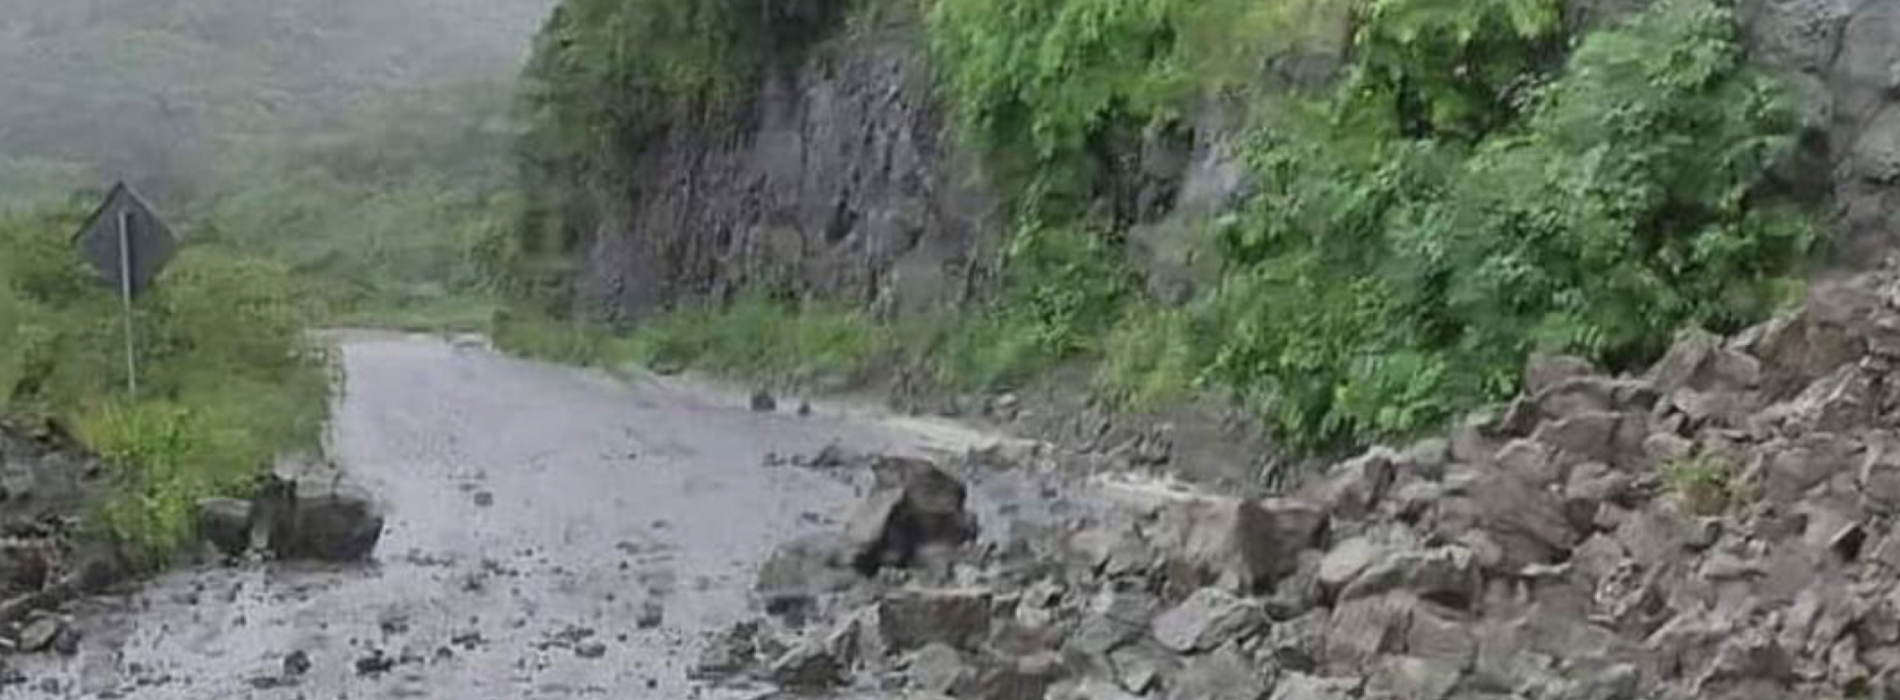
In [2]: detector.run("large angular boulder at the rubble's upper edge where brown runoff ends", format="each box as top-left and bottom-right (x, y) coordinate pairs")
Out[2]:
(1155, 496), (1326, 593)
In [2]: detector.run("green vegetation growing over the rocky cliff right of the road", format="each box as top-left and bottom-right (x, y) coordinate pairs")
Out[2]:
(524, 0), (1818, 451)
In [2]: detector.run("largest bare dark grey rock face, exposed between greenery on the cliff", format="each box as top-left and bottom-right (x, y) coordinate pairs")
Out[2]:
(580, 29), (992, 321)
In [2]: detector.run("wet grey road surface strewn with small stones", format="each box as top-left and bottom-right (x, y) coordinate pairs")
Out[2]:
(4, 333), (982, 700)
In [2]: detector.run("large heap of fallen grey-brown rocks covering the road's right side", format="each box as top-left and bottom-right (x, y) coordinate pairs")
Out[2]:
(716, 260), (1900, 700)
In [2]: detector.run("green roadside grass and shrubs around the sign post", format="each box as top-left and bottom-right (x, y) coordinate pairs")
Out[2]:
(0, 211), (329, 563)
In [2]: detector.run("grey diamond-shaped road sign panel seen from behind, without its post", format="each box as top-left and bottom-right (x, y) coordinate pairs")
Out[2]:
(72, 183), (177, 295)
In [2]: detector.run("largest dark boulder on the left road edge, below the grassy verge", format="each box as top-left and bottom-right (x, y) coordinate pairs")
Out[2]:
(270, 481), (382, 561)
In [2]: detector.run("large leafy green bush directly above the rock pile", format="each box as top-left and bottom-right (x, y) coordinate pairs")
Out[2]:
(1185, 0), (1815, 447)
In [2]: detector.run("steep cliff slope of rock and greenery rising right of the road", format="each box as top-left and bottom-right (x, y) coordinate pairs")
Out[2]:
(517, 0), (1900, 451)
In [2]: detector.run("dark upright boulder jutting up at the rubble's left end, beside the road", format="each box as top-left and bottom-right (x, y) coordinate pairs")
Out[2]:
(846, 457), (977, 574)
